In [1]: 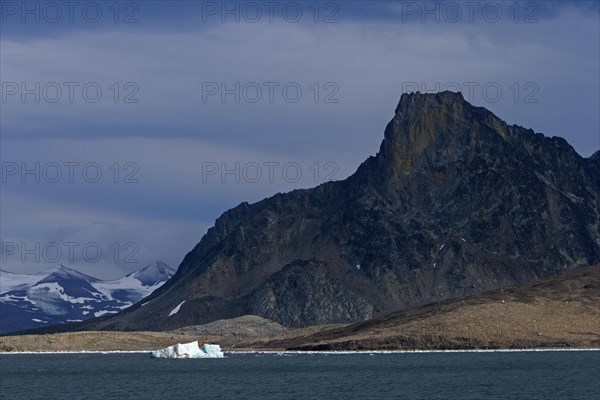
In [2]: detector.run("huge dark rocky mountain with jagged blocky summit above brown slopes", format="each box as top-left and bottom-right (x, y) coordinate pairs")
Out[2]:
(85, 92), (600, 330)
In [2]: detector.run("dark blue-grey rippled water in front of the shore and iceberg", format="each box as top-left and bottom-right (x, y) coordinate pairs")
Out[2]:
(0, 351), (600, 400)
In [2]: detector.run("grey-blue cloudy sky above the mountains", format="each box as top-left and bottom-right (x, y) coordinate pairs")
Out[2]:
(0, 0), (600, 279)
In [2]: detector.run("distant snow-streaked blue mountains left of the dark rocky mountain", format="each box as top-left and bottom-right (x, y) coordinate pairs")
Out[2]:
(0, 262), (175, 334)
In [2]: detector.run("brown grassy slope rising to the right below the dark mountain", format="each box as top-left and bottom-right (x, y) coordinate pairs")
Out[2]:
(264, 265), (600, 350)
